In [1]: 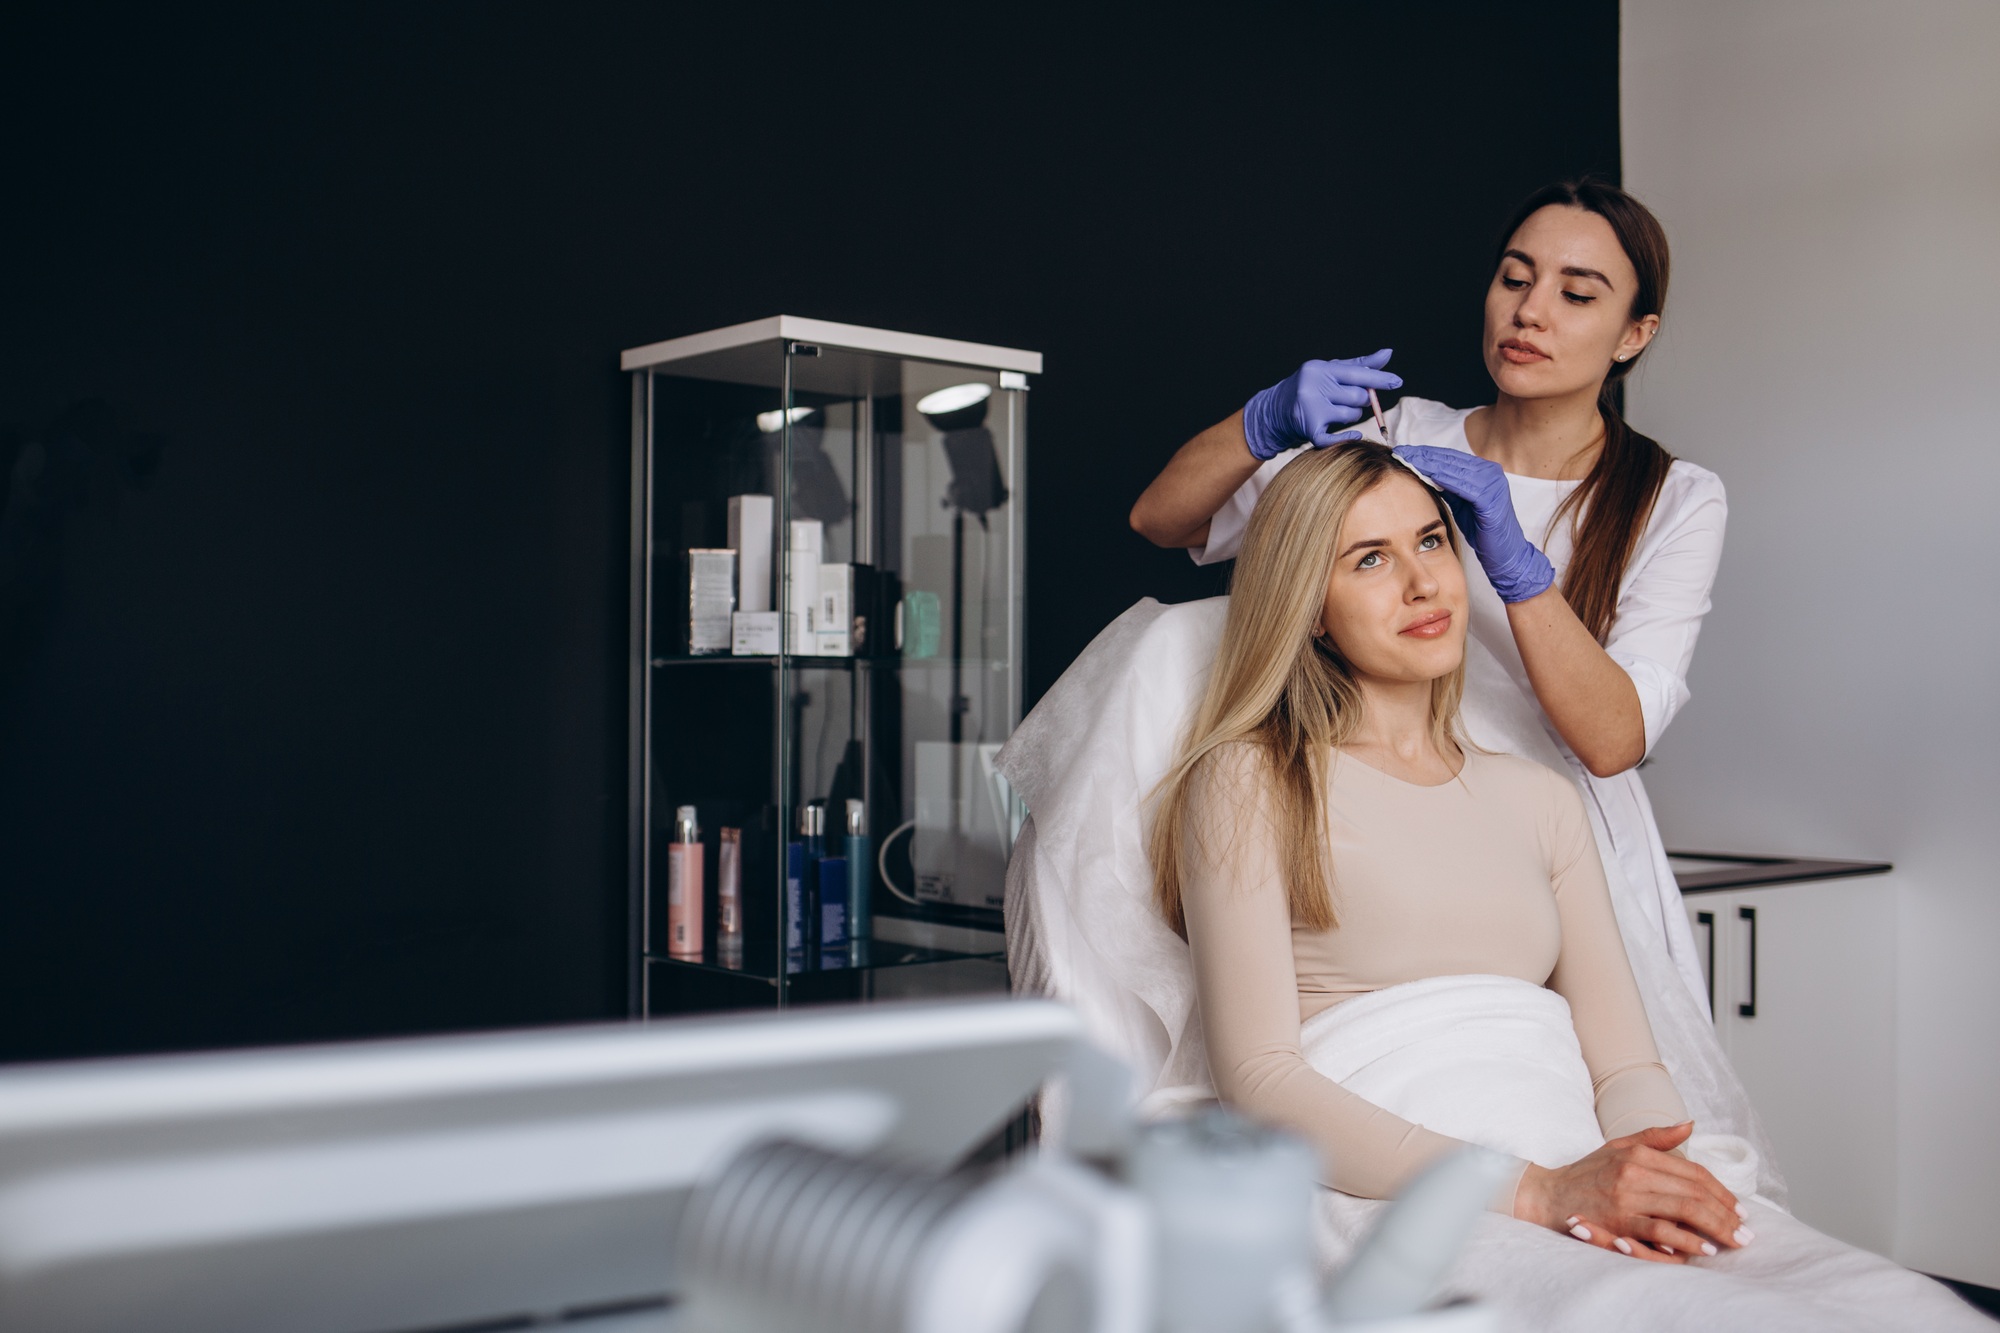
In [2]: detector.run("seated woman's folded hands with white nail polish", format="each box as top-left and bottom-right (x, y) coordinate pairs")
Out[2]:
(1514, 1121), (1754, 1263)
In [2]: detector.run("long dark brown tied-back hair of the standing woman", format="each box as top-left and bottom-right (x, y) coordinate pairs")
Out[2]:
(1494, 176), (1674, 642)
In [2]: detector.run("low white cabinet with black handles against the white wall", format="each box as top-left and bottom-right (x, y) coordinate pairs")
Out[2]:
(1686, 875), (1896, 1255)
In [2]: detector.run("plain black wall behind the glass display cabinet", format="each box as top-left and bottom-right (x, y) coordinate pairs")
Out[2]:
(0, 0), (1618, 1059)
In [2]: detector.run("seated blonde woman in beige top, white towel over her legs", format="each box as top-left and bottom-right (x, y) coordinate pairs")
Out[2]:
(1150, 442), (1976, 1327)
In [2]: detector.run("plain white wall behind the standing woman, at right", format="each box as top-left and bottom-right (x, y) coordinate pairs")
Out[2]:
(1622, 0), (2000, 1285)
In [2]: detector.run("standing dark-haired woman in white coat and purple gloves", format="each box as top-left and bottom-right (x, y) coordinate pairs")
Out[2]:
(1132, 180), (1728, 1009)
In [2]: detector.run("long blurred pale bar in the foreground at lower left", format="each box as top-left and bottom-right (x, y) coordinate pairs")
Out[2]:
(0, 1001), (1090, 1333)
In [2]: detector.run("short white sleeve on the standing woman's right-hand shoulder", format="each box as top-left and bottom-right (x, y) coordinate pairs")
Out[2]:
(1604, 468), (1730, 755)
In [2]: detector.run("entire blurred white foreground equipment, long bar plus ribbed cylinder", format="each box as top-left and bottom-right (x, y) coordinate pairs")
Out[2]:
(0, 1001), (1492, 1333)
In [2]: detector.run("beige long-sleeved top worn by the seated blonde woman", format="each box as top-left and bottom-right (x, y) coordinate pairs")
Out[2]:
(1182, 747), (1688, 1207)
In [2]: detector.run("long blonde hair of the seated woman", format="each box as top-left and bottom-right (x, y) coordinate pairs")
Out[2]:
(1150, 440), (1466, 937)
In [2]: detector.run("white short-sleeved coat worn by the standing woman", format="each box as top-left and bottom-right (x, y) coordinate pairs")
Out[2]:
(1190, 398), (1728, 1013)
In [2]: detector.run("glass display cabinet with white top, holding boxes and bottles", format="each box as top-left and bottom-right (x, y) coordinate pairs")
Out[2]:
(622, 316), (1042, 1017)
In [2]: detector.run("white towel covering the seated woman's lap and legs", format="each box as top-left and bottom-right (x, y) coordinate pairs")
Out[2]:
(1300, 977), (1992, 1333)
